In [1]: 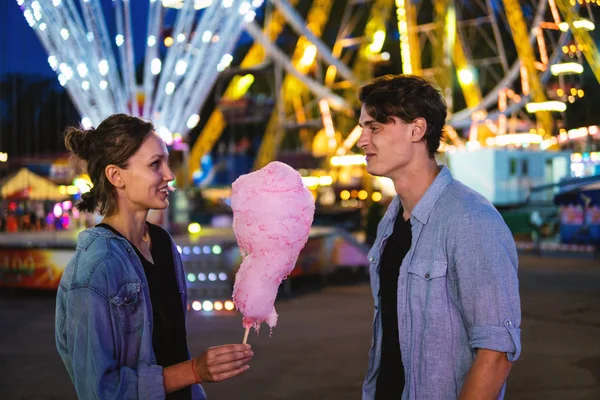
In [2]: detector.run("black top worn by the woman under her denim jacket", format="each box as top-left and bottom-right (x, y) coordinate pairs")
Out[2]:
(97, 222), (192, 400)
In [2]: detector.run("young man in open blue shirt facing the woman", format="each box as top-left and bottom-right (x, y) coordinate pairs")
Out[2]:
(358, 75), (521, 400)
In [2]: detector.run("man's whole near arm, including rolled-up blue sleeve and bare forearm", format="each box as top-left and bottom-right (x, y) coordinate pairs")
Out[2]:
(450, 209), (521, 400)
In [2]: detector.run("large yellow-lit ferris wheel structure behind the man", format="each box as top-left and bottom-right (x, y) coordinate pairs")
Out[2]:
(190, 0), (600, 172)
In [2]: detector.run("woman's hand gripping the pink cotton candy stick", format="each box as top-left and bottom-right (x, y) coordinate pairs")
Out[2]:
(192, 344), (254, 383)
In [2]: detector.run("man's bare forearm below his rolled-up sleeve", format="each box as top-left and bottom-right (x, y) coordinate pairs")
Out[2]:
(459, 349), (512, 400)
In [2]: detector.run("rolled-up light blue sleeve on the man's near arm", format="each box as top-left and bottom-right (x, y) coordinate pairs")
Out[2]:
(450, 209), (521, 362)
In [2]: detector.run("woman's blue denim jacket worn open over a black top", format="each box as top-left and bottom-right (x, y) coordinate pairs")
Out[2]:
(55, 227), (206, 399)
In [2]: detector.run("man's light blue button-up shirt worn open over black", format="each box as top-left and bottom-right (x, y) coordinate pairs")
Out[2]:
(362, 167), (521, 400)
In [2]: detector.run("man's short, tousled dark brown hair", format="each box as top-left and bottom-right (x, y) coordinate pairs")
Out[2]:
(359, 75), (447, 158)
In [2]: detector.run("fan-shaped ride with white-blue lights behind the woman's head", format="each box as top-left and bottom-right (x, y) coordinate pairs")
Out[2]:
(17, 0), (263, 143)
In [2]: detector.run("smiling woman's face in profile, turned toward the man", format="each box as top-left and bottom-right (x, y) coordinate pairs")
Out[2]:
(120, 133), (175, 211)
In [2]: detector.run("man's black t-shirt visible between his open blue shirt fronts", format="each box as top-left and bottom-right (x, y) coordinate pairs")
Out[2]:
(375, 208), (412, 400)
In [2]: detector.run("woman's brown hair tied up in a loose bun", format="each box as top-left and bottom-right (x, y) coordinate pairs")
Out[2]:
(65, 114), (154, 215)
